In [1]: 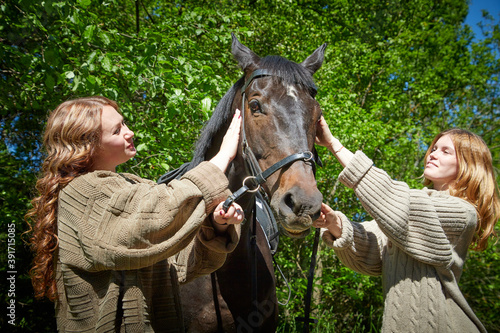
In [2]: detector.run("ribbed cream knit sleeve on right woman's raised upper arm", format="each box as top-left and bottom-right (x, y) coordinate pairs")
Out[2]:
(339, 151), (475, 266)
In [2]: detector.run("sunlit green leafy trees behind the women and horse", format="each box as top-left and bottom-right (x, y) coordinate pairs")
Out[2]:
(0, 0), (500, 332)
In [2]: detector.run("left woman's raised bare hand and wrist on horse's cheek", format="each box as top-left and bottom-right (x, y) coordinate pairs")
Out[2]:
(210, 109), (241, 172)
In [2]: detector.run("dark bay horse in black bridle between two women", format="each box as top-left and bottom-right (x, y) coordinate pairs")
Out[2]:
(175, 35), (326, 332)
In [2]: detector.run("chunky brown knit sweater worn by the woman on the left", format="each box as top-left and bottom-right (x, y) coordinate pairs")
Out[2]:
(56, 162), (239, 332)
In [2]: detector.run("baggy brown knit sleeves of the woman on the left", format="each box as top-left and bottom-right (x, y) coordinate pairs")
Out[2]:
(58, 162), (238, 272)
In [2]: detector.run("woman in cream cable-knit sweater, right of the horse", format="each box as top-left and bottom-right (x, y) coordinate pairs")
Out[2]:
(314, 118), (500, 332)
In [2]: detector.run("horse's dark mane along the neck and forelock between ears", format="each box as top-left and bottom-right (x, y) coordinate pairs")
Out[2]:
(189, 55), (314, 169)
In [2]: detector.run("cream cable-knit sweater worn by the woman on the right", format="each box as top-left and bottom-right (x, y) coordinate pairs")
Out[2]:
(323, 151), (486, 333)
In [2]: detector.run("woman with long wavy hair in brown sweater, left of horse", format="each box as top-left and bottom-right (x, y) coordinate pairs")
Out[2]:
(27, 96), (243, 332)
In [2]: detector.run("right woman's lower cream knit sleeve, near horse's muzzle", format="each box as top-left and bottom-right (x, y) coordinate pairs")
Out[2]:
(321, 212), (387, 276)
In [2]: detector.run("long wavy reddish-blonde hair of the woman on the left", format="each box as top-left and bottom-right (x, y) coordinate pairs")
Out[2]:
(25, 96), (118, 301)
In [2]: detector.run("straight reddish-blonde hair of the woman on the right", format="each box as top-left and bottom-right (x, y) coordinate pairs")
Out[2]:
(424, 129), (500, 251)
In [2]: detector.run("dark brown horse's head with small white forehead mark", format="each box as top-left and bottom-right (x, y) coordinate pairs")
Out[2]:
(231, 35), (326, 238)
